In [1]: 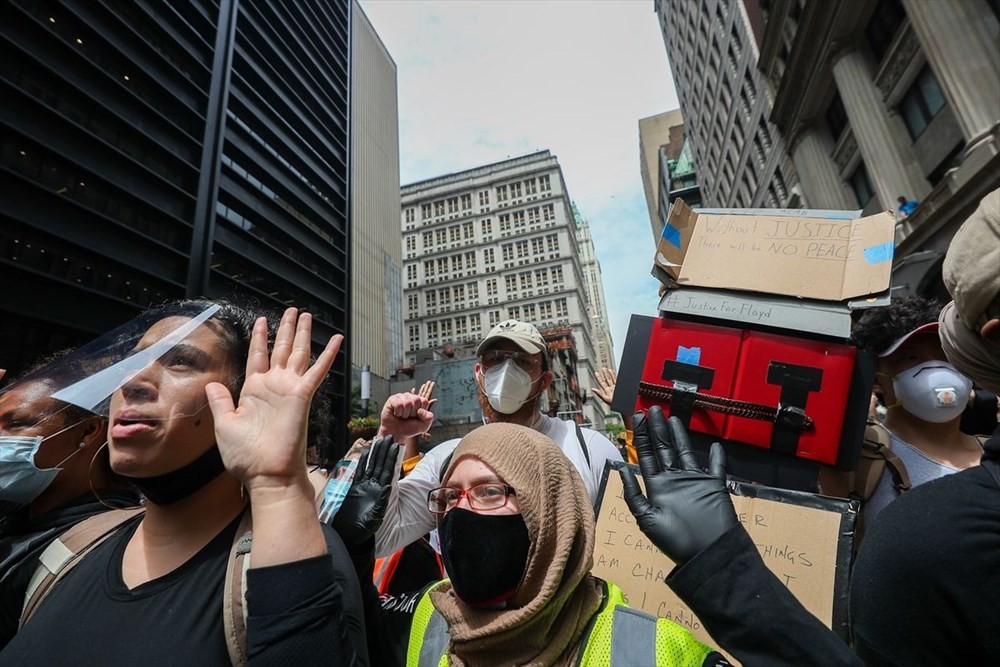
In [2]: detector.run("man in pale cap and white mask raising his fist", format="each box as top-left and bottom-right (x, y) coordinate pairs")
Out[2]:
(376, 320), (622, 556)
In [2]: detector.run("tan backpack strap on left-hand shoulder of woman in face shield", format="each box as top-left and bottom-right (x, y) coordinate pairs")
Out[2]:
(18, 507), (145, 627)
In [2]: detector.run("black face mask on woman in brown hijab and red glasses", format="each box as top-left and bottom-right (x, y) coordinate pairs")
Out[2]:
(438, 507), (531, 607)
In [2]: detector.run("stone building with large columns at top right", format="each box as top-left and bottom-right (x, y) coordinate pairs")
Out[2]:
(748, 0), (1000, 296)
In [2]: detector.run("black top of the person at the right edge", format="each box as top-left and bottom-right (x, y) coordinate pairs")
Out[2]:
(850, 431), (1000, 666)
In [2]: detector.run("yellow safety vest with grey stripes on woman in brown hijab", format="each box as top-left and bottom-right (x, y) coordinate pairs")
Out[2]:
(406, 581), (715, 667)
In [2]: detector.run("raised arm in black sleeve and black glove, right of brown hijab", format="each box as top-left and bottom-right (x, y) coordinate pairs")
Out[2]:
(622, 406), (861, 667)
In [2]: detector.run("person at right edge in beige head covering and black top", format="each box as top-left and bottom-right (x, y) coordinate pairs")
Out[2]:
(850, 190), (1000, 665)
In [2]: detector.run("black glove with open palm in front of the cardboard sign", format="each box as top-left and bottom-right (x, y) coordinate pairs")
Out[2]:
(621, 406), (737, 565)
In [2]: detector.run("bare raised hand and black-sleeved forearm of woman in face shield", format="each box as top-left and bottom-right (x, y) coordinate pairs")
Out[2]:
(205, 308), (368, 665)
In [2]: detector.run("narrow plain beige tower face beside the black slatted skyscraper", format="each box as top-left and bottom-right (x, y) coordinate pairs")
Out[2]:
(347, 0), (403, 411)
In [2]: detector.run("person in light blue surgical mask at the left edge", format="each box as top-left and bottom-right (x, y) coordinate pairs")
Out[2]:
(0, 354), (139, 648)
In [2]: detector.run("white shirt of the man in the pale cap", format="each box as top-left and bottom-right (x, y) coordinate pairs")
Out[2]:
(375, 413), (622, 556)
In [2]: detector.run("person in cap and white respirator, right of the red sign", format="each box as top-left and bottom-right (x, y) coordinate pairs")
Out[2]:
(851, 297), (982, 527)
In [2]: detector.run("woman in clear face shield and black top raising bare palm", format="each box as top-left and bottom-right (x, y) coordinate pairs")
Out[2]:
(0, 301), (368, 665)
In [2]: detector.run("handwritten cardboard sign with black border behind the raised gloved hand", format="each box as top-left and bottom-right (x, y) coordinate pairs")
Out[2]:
(593, 461), (858, 664)
